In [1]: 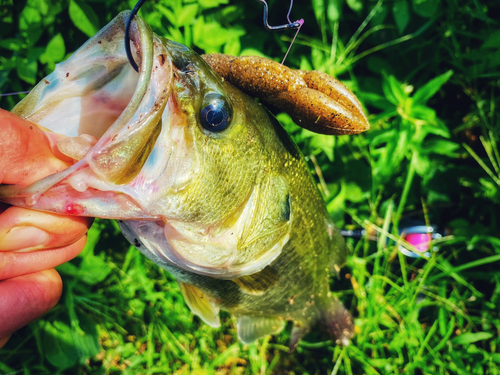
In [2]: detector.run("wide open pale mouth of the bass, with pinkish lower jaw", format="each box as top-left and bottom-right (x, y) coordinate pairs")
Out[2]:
(0, 12), (188, 220)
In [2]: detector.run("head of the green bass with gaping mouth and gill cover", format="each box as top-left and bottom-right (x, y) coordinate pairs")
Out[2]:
(0, 12), (296, 278)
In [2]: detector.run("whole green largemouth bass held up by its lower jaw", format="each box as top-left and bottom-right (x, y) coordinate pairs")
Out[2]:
(0, 13), (368, 347)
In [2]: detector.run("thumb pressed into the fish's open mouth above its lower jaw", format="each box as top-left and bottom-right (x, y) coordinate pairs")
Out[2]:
(0, 109), (71, 185)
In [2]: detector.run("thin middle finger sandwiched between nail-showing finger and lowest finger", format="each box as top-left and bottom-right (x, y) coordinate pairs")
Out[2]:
(0, 236), (87, 282)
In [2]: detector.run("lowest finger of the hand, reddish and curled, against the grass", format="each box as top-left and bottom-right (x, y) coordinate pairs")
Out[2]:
(0, 269), (62, 337)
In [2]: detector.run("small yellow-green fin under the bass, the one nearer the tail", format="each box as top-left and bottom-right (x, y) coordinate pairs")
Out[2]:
(236, 315), (285, 344)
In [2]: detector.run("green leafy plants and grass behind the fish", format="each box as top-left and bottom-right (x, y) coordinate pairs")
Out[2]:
(0, 0), (500, 375)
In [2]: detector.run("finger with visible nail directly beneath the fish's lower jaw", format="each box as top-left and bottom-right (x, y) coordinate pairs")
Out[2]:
(0, 207), (92, 252)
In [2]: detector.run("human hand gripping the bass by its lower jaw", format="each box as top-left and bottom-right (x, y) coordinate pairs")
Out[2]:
(0, 109), (92, 348)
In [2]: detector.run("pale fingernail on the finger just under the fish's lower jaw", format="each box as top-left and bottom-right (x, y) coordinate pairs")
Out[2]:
(0, 227), (49, 251)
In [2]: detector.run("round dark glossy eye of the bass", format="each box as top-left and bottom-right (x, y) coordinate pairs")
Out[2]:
(200, 94), (231, 132)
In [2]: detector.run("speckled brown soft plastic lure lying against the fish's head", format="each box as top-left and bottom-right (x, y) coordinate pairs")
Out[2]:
(202, 53), (370, 135)
